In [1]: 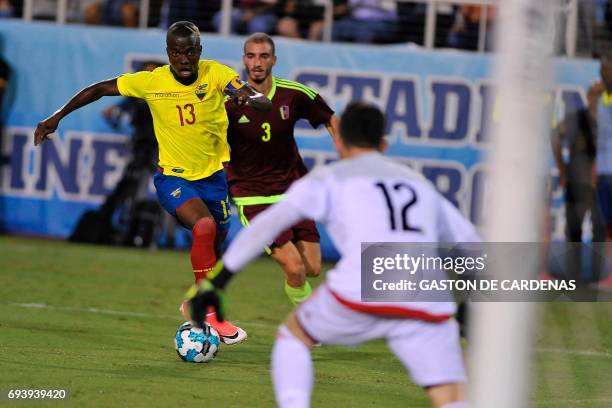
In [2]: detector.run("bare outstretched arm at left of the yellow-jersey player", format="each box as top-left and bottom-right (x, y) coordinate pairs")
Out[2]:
(34, 78), (120, 146)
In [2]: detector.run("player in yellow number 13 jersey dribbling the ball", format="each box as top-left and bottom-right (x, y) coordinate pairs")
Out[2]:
(34, 21), (271, 344)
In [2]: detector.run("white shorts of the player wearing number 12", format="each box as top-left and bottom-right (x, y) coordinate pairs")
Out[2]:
(295, 285), (465, 387)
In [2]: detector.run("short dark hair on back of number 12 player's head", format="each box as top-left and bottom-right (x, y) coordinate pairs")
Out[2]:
(340, 102), (385, 148)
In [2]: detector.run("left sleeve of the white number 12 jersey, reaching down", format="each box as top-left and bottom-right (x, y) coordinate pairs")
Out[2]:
(223, 176), (325, 272)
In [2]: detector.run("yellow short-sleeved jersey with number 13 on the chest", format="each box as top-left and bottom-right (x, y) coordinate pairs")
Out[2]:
(117, 60), (238, 180)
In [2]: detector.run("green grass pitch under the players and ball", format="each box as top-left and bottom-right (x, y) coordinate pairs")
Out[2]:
(0, 237), (612, 407)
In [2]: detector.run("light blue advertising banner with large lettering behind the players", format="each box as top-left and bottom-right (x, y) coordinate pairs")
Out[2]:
(0, 21), (598, 255)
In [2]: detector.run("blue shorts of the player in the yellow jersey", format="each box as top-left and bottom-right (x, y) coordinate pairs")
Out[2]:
(153, 170), (231, 231)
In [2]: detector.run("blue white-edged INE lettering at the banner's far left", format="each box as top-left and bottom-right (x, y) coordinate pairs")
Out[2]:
(2, 127), (128, 203)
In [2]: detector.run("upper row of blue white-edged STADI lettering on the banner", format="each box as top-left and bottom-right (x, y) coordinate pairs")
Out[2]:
(291, 68), (586, 143)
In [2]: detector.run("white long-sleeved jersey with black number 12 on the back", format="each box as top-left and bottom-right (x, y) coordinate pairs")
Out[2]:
(224, 152), (480, 314)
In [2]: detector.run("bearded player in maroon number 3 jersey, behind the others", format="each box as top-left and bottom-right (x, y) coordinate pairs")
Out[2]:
(225, 33), (338, 304)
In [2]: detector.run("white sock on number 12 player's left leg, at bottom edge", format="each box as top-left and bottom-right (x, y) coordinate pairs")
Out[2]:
(272, 325), (313, 408)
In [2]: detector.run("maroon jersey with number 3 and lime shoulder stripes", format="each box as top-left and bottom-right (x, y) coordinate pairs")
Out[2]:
(225, 78), (334, 197)
